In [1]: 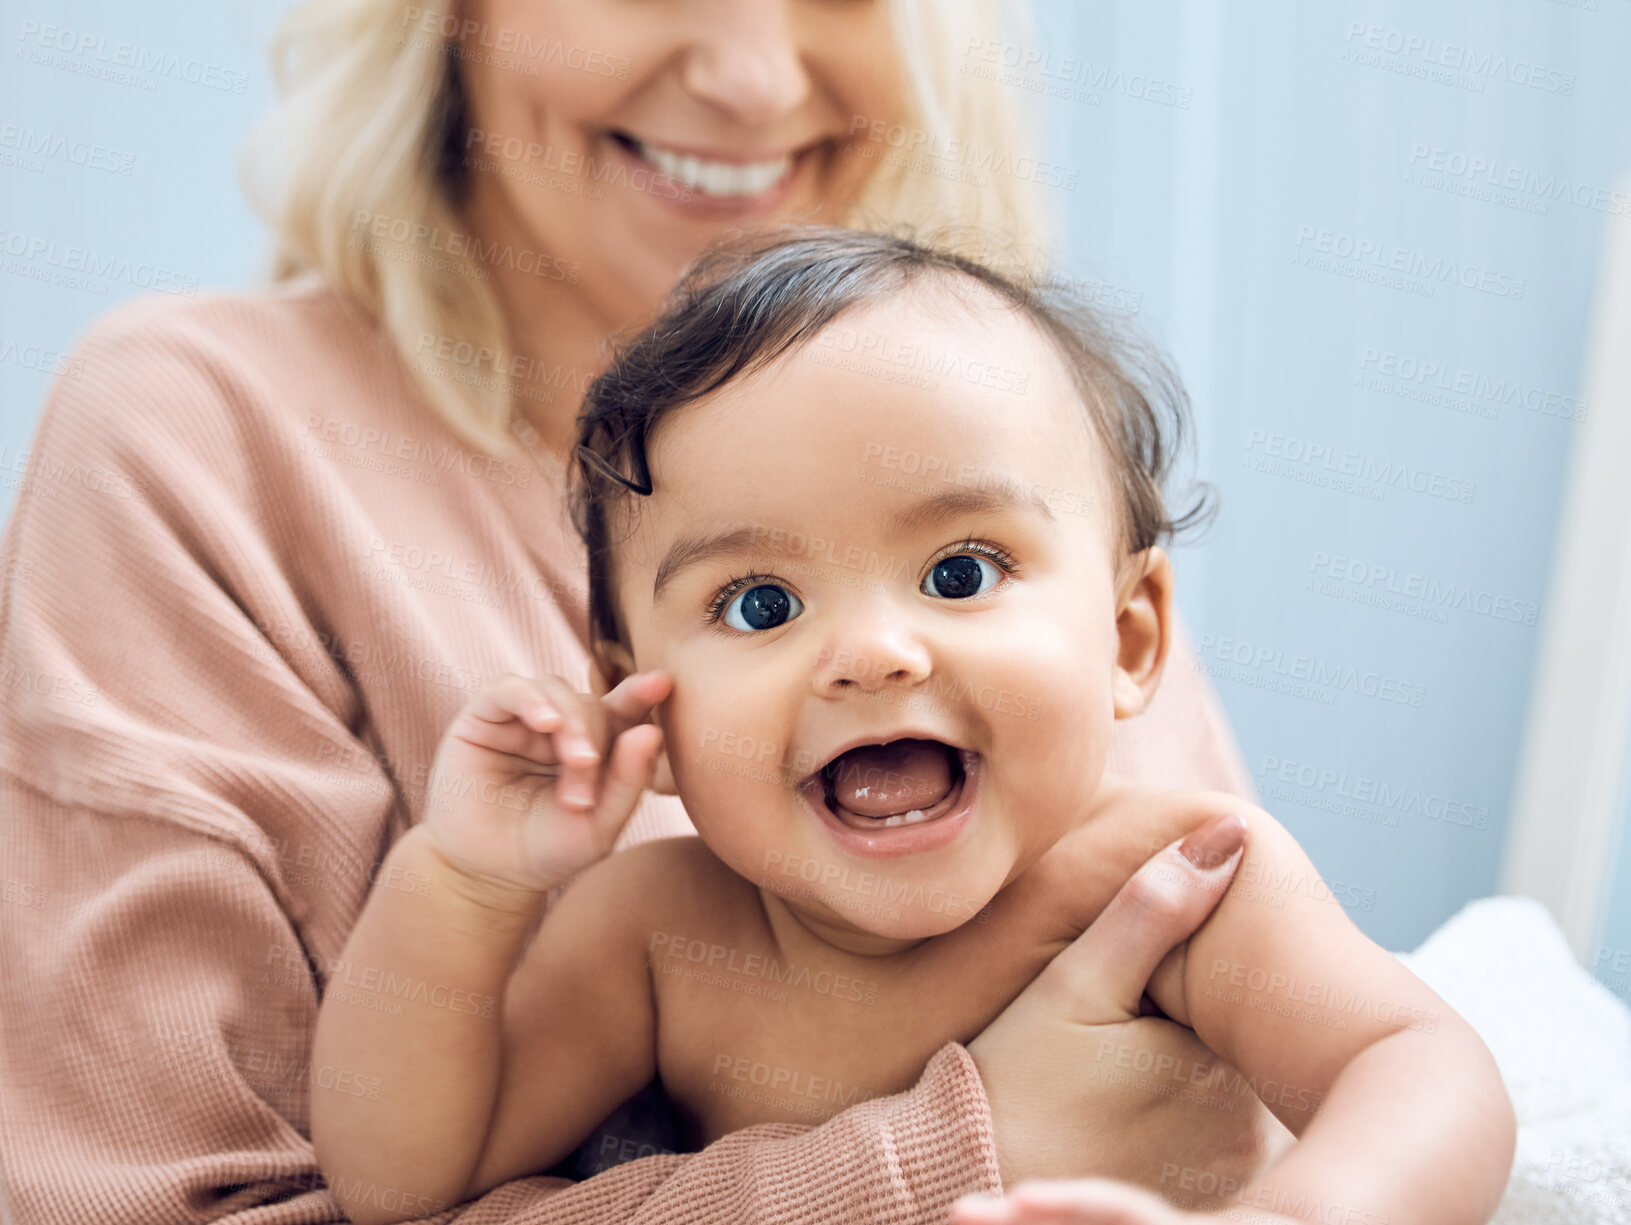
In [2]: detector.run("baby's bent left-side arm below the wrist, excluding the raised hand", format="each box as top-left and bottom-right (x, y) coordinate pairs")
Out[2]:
(312, 827), (654, 1225)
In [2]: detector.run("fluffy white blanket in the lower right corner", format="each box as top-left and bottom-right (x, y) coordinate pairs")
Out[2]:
(1398, 897), (1631, 1225)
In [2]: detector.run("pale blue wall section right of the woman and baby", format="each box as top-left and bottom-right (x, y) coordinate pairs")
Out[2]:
(1039, 0), (1631, 978)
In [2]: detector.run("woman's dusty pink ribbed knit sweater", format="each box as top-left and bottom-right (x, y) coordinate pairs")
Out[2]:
(0, 277), (1249, 1225)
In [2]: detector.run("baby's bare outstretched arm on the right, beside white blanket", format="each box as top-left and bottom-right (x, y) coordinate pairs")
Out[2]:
(1150, 801), (1515, 1225)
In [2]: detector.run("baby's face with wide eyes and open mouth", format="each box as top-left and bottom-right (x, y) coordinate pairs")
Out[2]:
(613, 290), (1165, 953)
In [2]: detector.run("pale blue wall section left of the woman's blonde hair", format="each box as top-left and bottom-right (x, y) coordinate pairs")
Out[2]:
(0, 0), (282, 514)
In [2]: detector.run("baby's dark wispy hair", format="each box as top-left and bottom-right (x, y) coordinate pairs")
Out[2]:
(571, 227), (1212, 643)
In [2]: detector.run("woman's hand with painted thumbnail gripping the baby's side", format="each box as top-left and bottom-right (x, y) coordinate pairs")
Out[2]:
(953, 816), (1292, 1200)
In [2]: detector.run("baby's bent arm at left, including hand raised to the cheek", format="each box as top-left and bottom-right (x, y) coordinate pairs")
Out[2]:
(312, 674), (670, 1225)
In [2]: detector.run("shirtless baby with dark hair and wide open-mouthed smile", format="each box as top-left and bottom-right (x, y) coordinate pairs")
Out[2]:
(312, 230), (1510, 1225)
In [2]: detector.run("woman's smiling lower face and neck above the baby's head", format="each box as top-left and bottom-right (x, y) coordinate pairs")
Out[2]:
(462, 0), (902, 353)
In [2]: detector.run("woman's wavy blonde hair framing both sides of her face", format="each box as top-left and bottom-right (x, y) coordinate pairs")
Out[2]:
(240, 0), (1054, 453)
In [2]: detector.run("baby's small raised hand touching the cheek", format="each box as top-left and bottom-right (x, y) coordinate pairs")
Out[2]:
(424, 672), (674, 892)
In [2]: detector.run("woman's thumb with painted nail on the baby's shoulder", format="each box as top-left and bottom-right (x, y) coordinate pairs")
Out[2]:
(1039, 812), (1246, 1024)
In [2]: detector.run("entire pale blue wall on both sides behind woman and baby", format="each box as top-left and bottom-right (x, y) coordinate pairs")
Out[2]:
(0, 0), (1631, 985)
